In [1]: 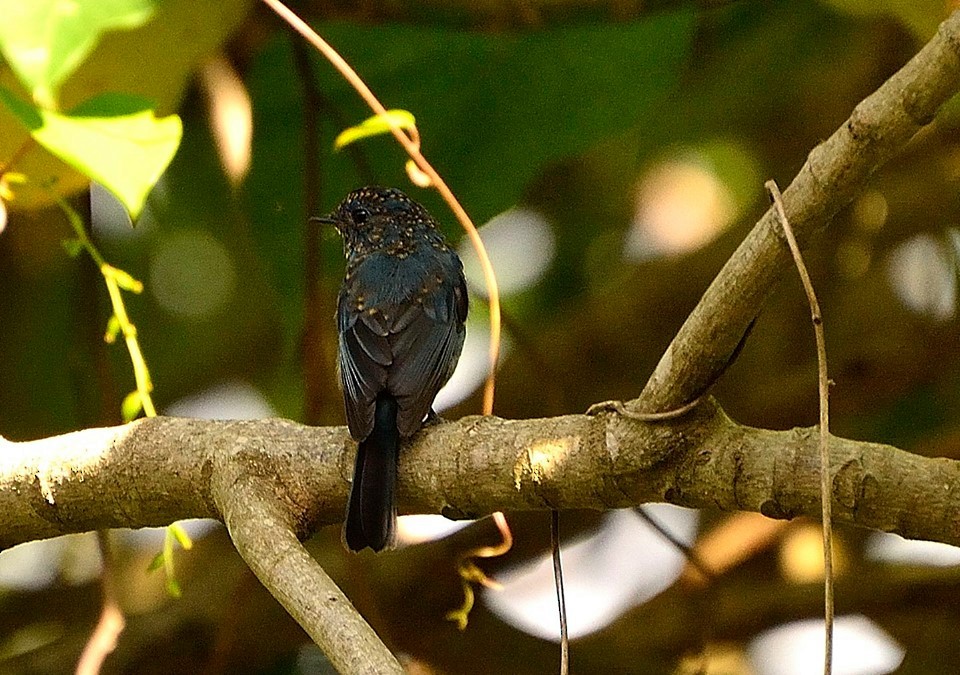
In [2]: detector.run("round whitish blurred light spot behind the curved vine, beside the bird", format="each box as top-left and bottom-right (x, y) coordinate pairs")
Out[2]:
(459, 208), (556, 297)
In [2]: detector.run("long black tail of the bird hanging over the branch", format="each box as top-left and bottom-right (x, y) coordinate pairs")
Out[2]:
(343, 394), (400, 552)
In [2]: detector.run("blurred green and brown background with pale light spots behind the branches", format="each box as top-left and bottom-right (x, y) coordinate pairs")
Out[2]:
(0, 0), (960, 675)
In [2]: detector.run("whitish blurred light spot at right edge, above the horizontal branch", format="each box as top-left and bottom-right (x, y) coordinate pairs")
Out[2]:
(887, 234), (957, 321)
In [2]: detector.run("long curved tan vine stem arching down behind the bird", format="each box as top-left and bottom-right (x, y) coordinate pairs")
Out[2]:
(263, 0), (500, 415)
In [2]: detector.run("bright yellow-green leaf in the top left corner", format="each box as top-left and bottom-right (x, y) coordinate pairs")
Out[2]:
(0, 0), (155, 107)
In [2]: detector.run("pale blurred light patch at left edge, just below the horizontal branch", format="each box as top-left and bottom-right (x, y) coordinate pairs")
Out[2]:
(0, 534), (101, 591)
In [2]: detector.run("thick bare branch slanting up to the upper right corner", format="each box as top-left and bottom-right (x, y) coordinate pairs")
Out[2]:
(638, 11), (960, 410)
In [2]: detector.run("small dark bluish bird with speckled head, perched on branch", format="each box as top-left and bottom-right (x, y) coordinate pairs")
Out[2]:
(316, 186), (469, 553)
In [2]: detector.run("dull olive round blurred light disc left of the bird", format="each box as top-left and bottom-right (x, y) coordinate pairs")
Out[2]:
(150, 230), (237, 319)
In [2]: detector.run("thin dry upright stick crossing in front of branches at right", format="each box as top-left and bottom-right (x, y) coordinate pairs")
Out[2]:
(764, 180), (833, 675)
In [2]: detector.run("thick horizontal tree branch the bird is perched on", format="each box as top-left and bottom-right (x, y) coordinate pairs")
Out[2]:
(0, 401), (960, 547)
